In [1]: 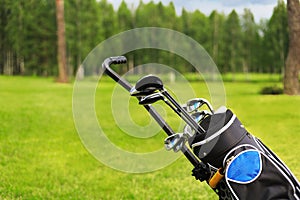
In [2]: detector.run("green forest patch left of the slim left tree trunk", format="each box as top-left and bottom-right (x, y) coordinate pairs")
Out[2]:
(0, 0), (57, 76)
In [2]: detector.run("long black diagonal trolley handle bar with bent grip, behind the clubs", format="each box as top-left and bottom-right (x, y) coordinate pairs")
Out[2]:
(102, 56), (200, 166)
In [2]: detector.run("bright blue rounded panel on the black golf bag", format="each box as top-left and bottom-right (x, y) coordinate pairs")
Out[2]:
(227, 150), (261, 183)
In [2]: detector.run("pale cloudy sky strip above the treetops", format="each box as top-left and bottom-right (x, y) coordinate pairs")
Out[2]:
(108, 0), (277, 22)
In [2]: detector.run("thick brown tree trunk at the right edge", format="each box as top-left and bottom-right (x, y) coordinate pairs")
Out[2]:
(284, 0), (300, 95)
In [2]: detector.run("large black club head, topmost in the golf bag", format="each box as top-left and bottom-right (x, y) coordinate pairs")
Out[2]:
(130, 74), (164, 96)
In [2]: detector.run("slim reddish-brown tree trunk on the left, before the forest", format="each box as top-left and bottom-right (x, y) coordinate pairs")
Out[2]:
(56, 0), (68, 83)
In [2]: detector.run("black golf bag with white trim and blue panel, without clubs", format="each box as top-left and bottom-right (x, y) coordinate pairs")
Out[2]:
(189, 108), (300, 200)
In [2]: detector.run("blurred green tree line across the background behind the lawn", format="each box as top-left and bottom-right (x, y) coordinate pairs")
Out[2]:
(0, 0), (289, 76)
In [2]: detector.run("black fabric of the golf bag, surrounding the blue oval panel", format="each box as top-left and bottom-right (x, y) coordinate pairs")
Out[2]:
(189, 110), (300, 200)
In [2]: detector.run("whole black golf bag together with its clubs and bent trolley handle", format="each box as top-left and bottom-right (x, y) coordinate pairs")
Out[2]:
(102, 56), (300, 200)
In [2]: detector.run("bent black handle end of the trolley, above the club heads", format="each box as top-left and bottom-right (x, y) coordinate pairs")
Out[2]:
(102, 56), (132, 91)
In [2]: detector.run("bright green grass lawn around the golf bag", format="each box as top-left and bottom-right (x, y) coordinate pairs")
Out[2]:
(0, 76), (300, 199)
